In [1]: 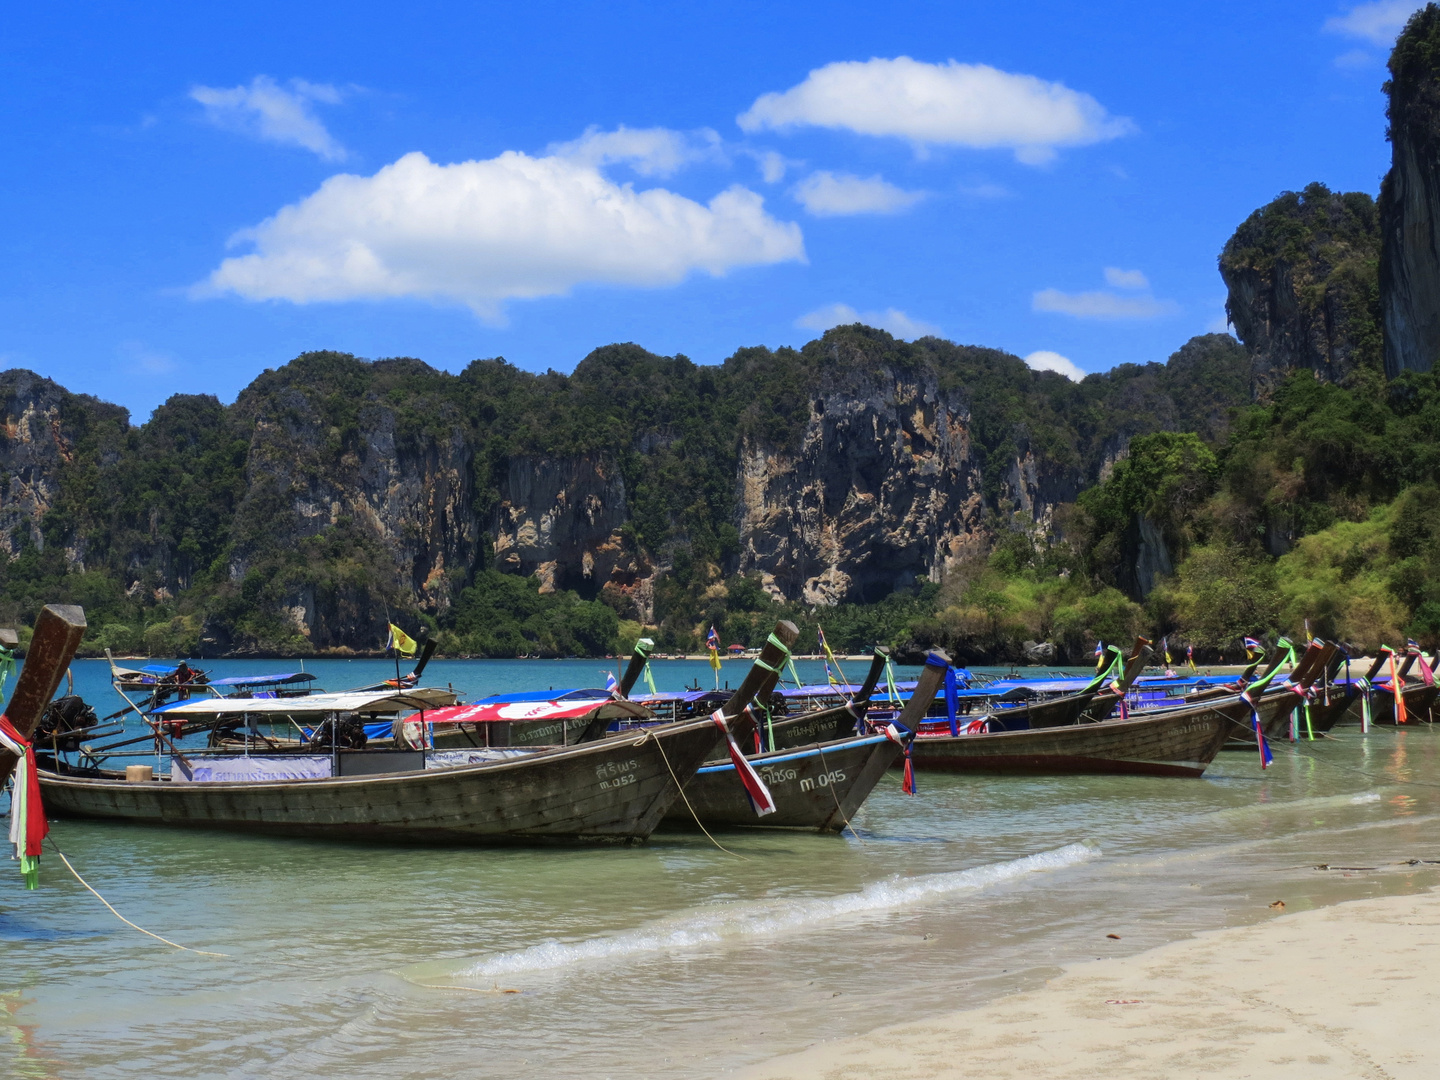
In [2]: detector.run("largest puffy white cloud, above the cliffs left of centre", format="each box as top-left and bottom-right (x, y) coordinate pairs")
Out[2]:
(200, 151), (805, 321)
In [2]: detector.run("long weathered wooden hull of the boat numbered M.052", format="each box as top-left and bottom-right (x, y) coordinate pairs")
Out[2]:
(40, 720), (716, 844)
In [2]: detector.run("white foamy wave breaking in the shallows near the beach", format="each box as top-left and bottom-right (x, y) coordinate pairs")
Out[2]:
(458, 844), (1100, 978)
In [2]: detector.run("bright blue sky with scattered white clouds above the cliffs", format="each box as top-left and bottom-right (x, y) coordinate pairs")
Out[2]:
(0, 0), (1416, 422)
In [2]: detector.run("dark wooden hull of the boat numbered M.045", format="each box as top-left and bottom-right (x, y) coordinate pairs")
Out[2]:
(665, 734), (900, 832)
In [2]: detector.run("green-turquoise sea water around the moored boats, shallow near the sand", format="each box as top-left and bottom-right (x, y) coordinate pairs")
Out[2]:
(0, 661), (1440, 1080)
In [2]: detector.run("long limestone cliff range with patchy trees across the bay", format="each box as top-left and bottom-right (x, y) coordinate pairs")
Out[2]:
(0, 327), (1243, 654)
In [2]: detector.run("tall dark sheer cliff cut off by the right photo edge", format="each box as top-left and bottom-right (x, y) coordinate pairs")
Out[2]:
(1380, 4), (1440, 379)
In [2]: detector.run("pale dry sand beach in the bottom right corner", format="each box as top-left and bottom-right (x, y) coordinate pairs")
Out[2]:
(742, 893), (1440, 1080)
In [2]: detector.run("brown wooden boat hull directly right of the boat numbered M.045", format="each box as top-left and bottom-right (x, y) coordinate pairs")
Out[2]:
(910, 700), (1250, 776)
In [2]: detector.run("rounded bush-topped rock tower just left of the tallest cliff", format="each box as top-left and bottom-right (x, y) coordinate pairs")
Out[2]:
(1220, 184), (1381, 399)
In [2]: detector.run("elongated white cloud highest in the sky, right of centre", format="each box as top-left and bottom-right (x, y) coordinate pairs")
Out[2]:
(737, 56), (1133, 164)
